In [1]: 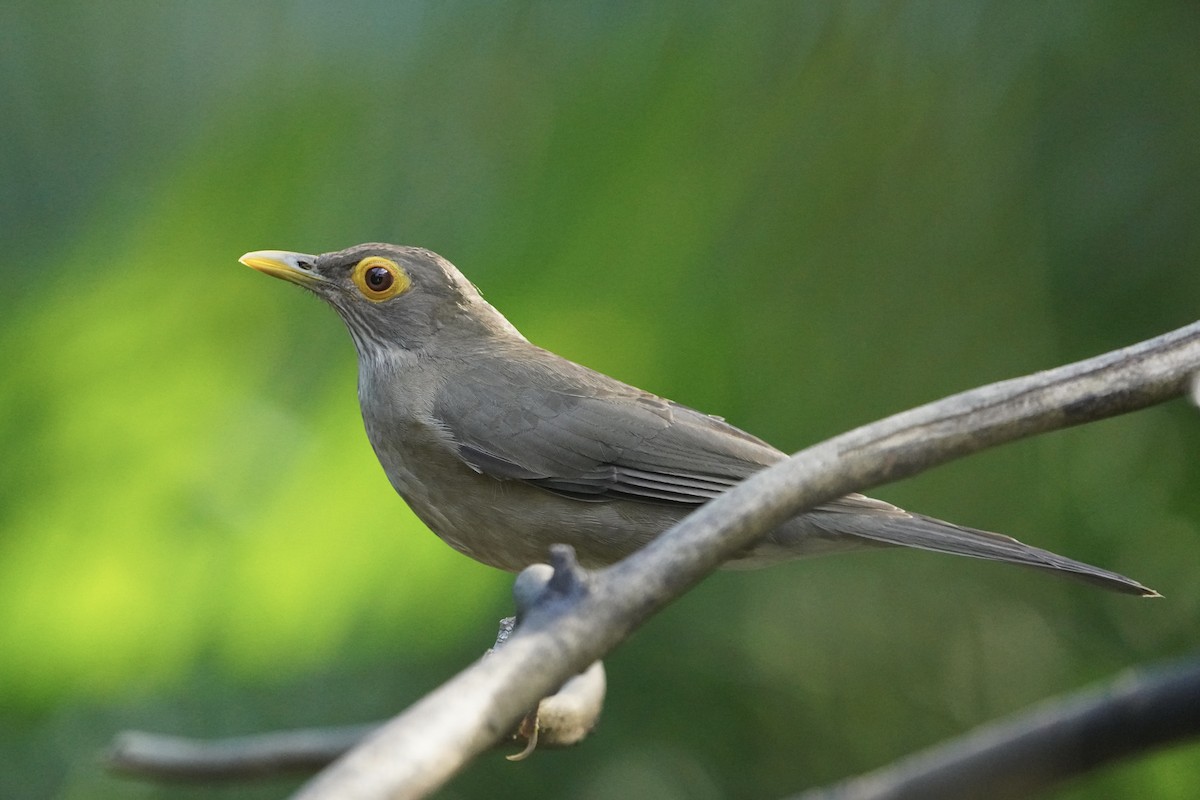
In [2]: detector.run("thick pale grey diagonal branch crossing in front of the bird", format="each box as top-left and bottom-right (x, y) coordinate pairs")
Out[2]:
(288, 323), (1200, 800)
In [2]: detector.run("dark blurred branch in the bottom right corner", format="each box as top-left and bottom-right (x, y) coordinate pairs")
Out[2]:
(796, 660), (1200, 800)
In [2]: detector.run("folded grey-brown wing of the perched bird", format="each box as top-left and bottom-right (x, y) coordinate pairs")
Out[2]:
(433, 344), (784, 505)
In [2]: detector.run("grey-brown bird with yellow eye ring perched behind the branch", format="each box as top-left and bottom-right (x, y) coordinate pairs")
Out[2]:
(239, 242), (1158, 596)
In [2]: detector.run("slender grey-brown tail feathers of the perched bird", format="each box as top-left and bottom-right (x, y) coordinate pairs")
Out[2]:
(844, 512), (1162, 597)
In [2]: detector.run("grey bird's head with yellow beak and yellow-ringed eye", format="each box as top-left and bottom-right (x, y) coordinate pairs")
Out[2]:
(239, 243), (521, 356)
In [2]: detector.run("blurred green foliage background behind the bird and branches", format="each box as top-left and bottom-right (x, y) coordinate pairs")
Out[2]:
(0, 0), (1200, 800)
